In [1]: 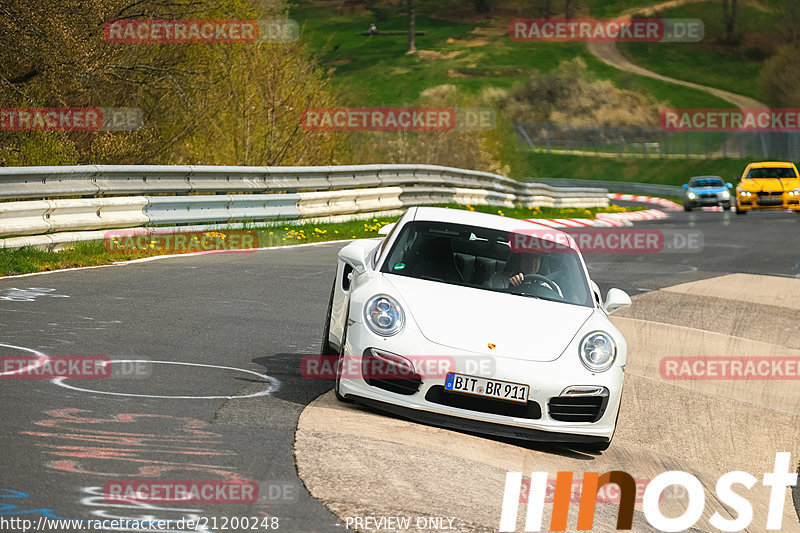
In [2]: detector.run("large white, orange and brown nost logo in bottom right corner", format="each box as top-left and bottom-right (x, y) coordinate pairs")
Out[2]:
(500, 452), (798, 532)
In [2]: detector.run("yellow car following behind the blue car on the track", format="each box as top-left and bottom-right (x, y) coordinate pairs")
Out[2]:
(736, 161), (800, 215)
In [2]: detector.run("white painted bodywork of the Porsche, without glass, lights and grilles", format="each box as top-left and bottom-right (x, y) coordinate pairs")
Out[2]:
(329, 208), (630, 440)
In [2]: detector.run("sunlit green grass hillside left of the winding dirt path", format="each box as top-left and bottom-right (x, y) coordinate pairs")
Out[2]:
(291, 6), (729, 107)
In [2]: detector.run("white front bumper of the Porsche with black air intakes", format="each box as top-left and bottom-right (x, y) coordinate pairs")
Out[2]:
(338, 324), (624, 443)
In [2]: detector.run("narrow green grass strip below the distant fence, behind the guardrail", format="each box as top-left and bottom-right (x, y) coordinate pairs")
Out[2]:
(519, 153), (750, 186)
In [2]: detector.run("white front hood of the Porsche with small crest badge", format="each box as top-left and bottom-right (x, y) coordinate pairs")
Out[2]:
(384, 275), (594, 361)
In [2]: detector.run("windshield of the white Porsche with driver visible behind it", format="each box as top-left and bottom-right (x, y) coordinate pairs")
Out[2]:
(381, 221), (592, 307)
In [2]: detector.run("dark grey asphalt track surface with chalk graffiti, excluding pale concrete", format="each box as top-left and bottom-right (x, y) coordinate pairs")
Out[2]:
(0, 206), (800, 532)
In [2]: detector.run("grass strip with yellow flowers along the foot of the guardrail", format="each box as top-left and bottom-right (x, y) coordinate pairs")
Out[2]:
(0, 204), (629, 276)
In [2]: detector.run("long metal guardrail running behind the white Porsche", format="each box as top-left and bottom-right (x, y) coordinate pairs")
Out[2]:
(0, 165), (608, 248)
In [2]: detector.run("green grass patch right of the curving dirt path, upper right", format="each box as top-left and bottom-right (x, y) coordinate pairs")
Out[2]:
(617, 2), (777, 103)
